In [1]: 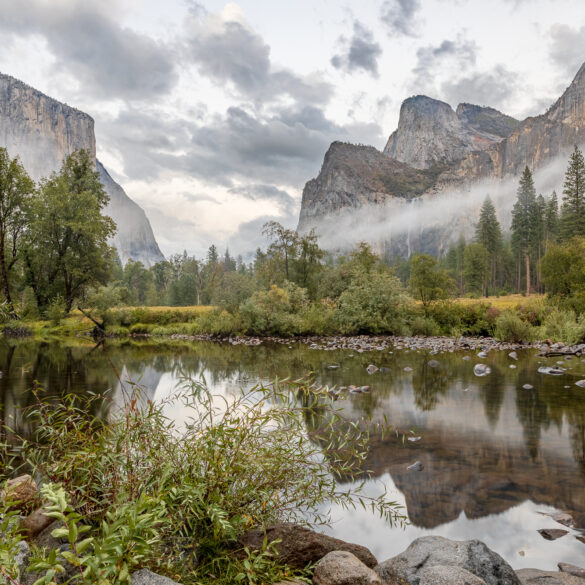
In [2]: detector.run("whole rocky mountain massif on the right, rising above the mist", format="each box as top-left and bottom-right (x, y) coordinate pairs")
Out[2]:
(298, 64), (585, 251)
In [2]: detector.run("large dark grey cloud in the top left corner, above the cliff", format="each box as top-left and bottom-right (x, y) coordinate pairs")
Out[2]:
(0, 0), (178, 100)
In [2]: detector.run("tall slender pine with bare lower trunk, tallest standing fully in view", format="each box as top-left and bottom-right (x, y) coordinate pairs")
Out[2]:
(511, 167), (538, 295)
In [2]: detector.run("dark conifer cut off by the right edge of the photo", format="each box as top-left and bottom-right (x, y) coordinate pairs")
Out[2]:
(561, 146), (585, 240)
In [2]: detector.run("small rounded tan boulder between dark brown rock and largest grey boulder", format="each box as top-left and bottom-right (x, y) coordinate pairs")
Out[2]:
(313, 550), (382, 585)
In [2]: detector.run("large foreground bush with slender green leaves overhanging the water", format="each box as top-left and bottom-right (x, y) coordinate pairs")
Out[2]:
(14, 381), (404, 585)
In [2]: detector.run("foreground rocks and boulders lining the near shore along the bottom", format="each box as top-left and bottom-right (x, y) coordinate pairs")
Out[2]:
(6, 475), (585, 585)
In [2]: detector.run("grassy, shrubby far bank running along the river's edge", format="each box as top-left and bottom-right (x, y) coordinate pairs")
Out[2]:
(2, 287), (585, 344)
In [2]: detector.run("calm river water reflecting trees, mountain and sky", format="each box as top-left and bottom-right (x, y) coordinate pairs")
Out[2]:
(0, 341), (585, 569)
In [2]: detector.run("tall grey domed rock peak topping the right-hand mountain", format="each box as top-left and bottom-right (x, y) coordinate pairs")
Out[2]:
(384, 95), (518, 169)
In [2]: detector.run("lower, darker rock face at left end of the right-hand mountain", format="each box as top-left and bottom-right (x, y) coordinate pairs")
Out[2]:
(298, 142), (437, 231)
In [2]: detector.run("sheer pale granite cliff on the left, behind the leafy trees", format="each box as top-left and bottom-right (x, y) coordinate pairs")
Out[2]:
(0, 73), (164, 266)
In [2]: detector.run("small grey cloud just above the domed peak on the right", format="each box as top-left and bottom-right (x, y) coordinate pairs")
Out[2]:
(441, 65), (518, 108)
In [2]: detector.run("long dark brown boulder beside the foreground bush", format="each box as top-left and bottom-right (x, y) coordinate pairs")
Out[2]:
(238, 522), (378, 569)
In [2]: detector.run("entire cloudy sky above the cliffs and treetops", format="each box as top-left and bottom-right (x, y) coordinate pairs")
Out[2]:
(0, 0), (585, 256)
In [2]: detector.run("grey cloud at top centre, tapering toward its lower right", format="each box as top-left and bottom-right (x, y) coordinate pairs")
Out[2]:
(187, 22), (333, 103)
